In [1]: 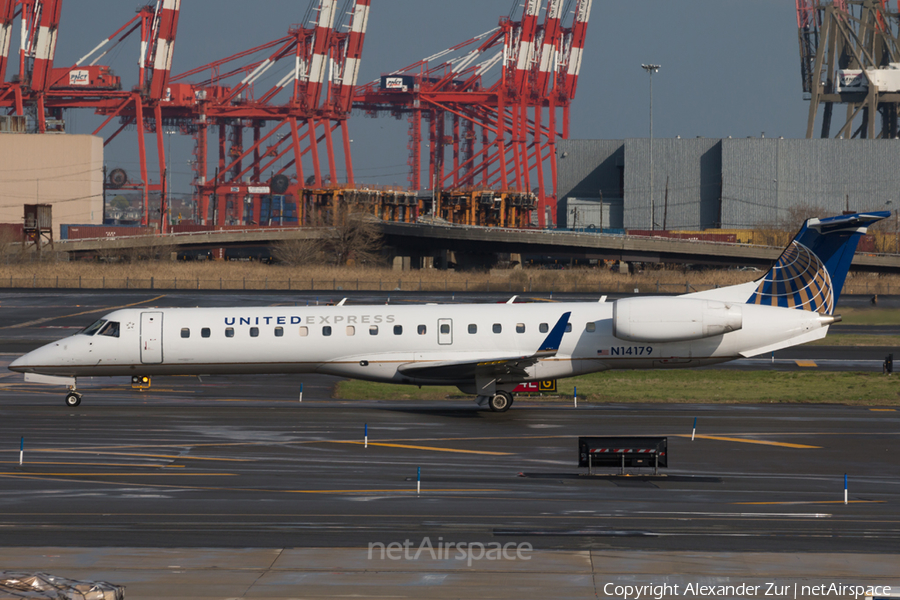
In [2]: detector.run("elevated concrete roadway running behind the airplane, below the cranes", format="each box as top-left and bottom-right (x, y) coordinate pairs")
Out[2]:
(57, 223), (900, 272)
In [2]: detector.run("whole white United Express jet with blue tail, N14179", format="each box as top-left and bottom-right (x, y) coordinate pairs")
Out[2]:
(9, 212), (890, 412)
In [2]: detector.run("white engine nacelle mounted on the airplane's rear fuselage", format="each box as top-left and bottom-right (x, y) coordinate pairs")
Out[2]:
(613, 298), (743, 343)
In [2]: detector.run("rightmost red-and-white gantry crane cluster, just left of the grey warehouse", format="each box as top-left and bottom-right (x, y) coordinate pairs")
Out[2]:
(354, 0), (592, 226)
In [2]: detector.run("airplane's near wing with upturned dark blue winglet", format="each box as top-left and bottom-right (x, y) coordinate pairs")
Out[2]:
(398, 312), (572, 382)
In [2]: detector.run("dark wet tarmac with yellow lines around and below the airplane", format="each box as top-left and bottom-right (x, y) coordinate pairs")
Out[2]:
(0, 293), (900, 598)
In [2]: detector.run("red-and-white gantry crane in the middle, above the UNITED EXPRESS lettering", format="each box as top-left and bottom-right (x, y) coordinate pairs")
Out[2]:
(170, 0), (370, 225)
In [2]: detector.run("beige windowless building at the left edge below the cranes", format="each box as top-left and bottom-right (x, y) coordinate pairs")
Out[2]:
(0, 133), (103, 239)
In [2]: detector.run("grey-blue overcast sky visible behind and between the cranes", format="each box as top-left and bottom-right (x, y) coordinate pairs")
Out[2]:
(44, 0), (808, 191)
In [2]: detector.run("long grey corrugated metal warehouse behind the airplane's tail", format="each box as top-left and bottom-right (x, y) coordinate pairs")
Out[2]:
(557, 138), (900, 229)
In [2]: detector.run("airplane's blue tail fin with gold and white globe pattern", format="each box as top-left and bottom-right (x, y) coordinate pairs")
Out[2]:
(747, 212), (891, 315)
